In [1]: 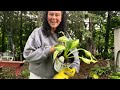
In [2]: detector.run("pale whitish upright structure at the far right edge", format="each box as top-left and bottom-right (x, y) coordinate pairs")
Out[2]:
(114, 28), (120, 71)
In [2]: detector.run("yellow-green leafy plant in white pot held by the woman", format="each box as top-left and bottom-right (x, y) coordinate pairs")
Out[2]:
(53, 32), (97, 72)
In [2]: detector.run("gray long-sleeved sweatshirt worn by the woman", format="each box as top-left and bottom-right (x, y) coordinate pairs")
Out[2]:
(23, 27), (80, 78)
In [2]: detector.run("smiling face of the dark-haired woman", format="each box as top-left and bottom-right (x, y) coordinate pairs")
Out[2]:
(47, 11), (62, 31)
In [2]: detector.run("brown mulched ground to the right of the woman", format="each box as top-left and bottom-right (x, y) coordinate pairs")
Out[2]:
(71, 60), (113, 79)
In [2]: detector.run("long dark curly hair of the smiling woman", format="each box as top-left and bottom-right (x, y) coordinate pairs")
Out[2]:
(43, 11), (68, 37)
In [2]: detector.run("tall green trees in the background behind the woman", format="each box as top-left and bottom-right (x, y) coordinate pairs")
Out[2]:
(0, 11), (120, 60)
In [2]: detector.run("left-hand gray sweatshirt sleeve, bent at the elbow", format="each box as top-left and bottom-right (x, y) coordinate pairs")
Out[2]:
(23, 31), (51, 63)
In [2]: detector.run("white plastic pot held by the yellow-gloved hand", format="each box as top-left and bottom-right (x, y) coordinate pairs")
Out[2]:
(54, 58), (71, 72)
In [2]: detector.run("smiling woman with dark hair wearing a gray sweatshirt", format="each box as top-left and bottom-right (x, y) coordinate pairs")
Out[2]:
(23, 11), (80, 79)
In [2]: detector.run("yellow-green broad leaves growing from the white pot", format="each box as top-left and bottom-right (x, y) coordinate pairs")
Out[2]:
(53, 32), (97, 64)
